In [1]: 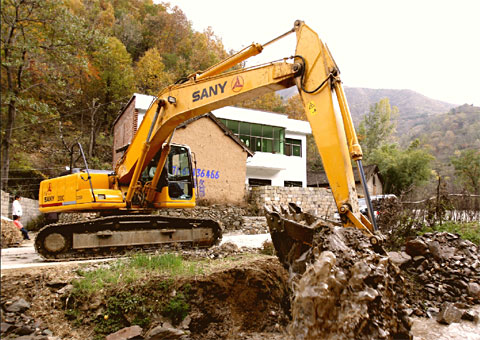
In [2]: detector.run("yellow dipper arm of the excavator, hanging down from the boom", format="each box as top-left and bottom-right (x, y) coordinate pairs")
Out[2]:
(296, 25), (359, 219)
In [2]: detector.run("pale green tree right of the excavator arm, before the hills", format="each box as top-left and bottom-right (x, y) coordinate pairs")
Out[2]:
(358, 98), (398, 162)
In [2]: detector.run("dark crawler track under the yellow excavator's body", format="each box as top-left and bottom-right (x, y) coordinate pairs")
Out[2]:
(35, 215), (222, 261)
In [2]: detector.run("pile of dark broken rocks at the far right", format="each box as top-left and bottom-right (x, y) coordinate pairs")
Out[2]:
(389, 232), (480, 316)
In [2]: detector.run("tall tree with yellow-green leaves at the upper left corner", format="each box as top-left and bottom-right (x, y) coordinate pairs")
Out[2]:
(1, 0), (91, 188)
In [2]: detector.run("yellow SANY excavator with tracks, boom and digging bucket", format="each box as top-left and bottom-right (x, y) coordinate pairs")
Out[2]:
(35, 20), (376, 260)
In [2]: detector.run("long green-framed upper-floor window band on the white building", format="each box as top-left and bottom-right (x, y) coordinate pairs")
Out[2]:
(220, 119), (285, 155)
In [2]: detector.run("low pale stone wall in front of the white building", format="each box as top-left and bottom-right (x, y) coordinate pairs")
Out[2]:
(249, 186), (337, 218)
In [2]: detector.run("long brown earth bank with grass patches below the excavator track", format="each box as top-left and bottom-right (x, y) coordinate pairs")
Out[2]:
(1, 255), (291, 340)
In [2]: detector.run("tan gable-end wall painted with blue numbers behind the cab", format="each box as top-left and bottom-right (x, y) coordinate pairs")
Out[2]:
(173, 117), (247, 205)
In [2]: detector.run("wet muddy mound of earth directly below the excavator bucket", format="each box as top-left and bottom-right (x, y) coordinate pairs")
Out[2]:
(289, 227), (411, 340)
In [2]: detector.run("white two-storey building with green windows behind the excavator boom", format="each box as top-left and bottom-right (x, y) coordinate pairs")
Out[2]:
(212, 106), (312, 187)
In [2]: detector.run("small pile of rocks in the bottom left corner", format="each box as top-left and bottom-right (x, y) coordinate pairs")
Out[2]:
(0, 297), (60, 340)
